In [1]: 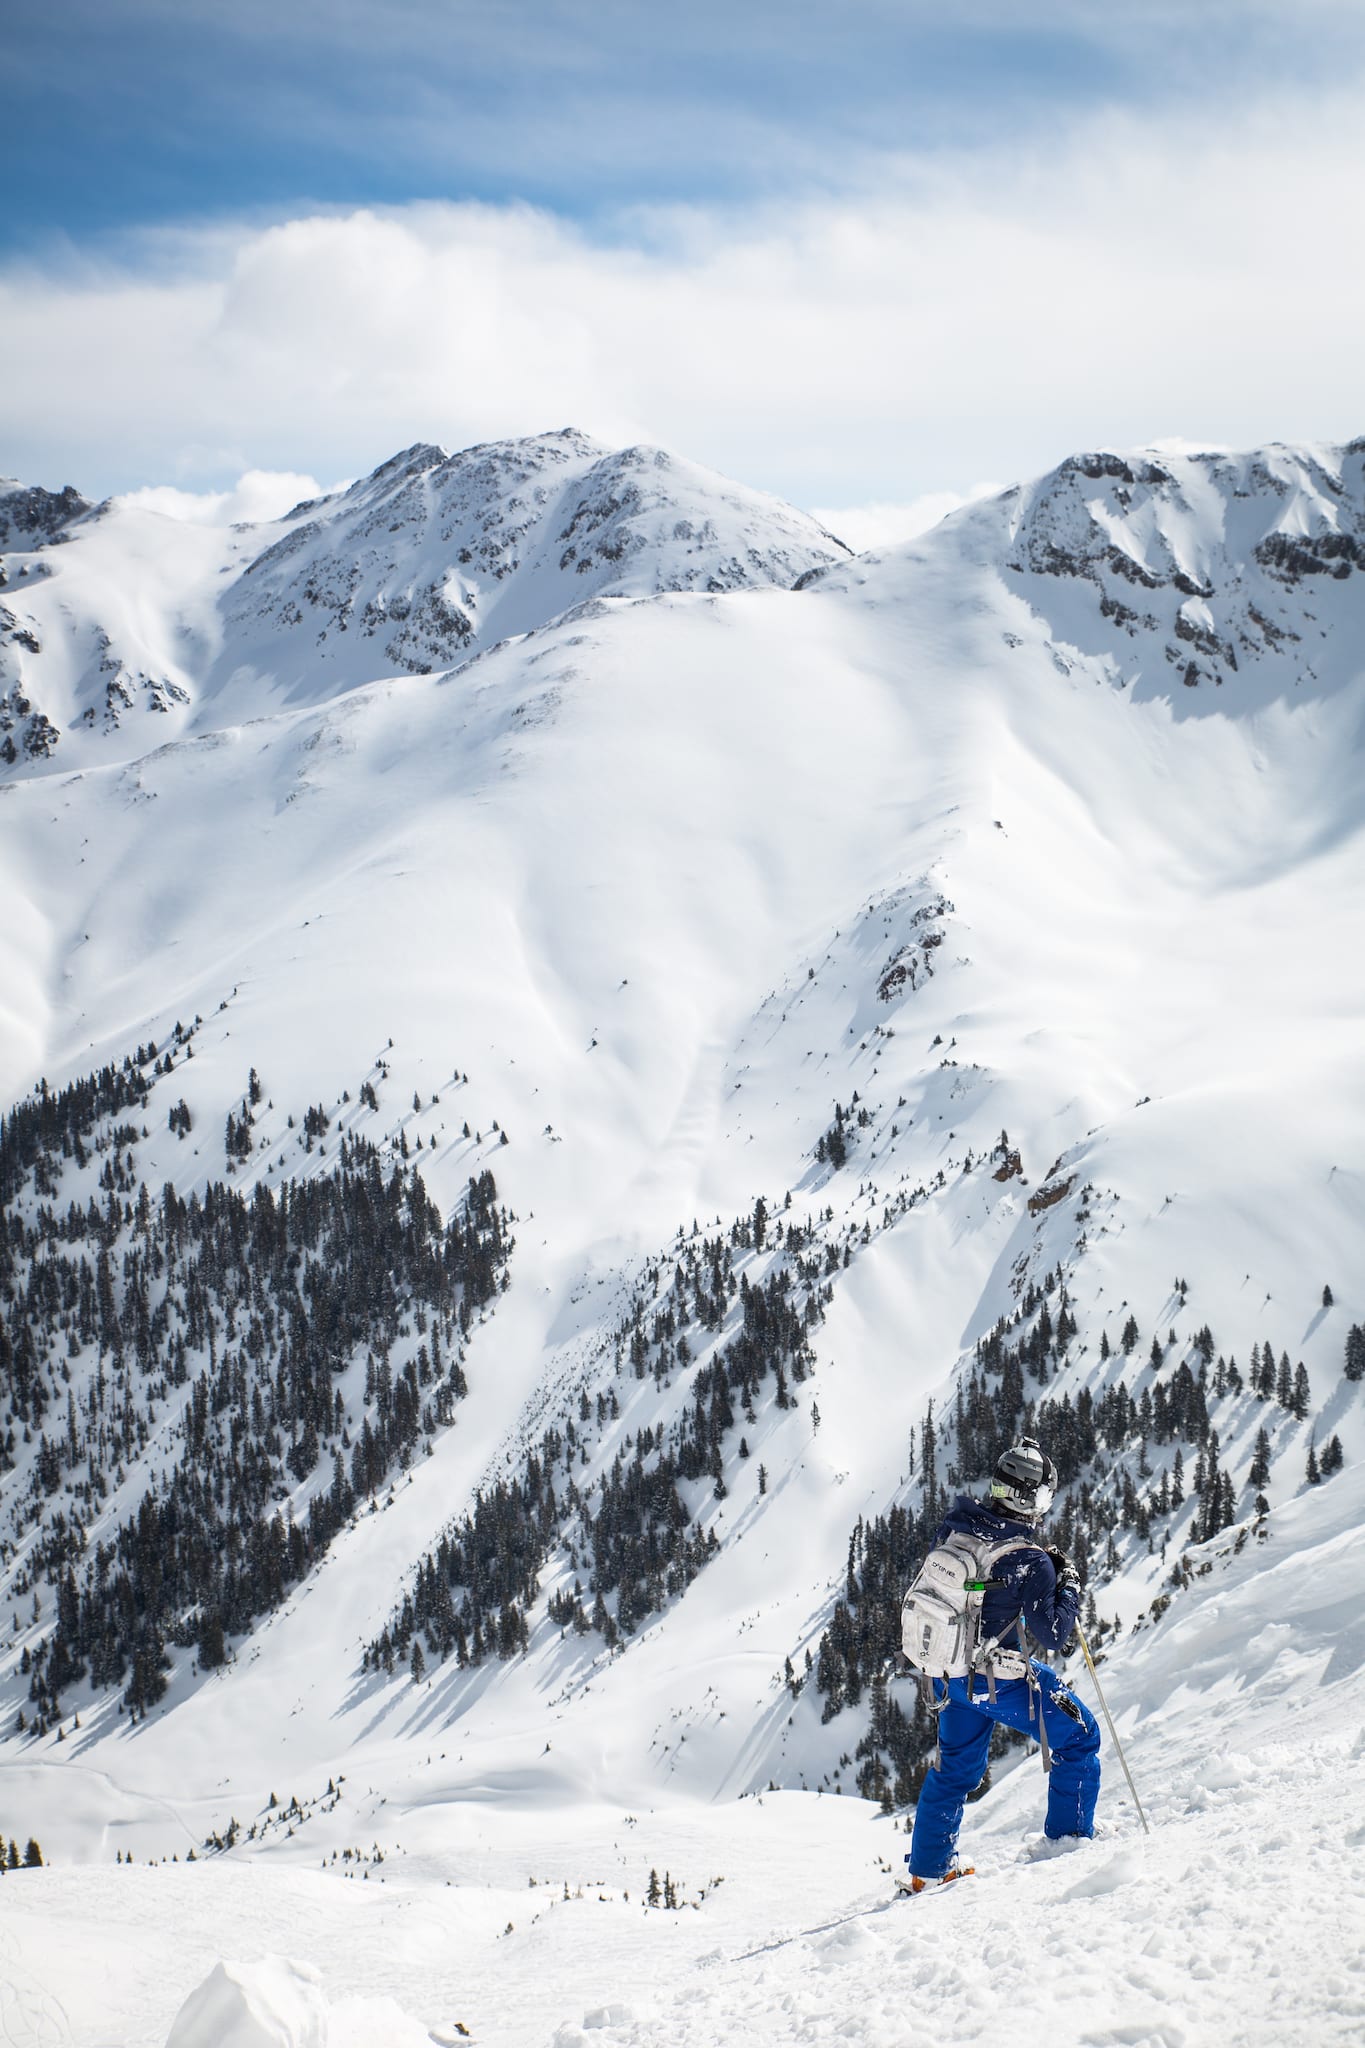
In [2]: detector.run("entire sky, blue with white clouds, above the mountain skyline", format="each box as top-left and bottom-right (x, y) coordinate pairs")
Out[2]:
(0, 0), (1365, 504)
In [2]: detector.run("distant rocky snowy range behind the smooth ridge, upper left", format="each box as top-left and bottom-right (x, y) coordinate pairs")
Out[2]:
(0, 430), (847, 772)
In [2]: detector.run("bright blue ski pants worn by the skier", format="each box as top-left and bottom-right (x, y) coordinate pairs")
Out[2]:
(907, 1659), (1099, 1878)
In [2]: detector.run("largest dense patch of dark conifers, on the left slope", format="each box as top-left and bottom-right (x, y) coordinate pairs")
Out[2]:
(0, 1038), (510, 1733)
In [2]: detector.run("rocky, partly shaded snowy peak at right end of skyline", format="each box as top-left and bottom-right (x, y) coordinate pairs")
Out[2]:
(810, 440), (1365, 713)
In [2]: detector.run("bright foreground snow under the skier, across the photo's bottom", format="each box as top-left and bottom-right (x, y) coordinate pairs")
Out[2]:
(0, 1493), (1365, 2048)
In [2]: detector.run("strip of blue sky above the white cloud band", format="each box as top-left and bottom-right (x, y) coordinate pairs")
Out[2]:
(0, 0), (1363, 248)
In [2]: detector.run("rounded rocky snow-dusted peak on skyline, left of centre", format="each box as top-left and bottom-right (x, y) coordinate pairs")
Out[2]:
(219, 428), (845, 694)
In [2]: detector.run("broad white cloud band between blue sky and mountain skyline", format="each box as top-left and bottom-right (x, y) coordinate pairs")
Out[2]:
(0, 92), (1365, 506)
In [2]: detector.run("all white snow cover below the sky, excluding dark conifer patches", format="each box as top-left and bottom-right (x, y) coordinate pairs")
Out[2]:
(0, 436), (1365, 2048)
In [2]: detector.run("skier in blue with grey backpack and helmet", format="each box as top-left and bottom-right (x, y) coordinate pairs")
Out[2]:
(896, 1436), (1099, 1894)
